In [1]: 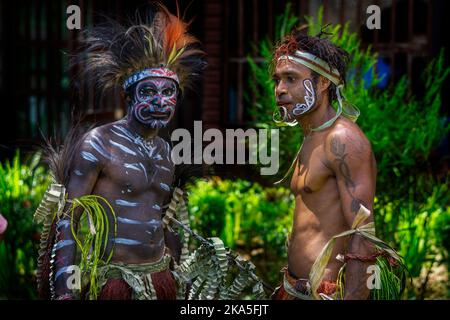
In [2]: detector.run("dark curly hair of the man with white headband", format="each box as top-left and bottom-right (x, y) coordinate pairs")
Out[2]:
(270, 26), (350, 102)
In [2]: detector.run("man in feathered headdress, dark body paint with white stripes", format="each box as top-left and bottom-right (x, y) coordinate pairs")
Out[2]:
(37, 6), (205, 299)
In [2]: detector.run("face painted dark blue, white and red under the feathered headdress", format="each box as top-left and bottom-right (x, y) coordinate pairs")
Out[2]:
(132, 78), (178, 129)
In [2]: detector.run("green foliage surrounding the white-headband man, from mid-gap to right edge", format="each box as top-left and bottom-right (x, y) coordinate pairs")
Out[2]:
(190, 6), (450, 299)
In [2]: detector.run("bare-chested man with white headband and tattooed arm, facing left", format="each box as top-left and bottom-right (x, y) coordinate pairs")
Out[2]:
(273, 31), (376, 299)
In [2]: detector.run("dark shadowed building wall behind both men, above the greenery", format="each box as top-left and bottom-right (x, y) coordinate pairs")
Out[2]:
(0, 0), (450, 176)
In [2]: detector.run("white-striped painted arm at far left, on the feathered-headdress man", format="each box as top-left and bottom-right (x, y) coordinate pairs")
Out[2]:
(53, 140), (101, 299)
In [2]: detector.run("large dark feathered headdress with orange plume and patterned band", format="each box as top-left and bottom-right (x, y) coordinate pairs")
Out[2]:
(72, 4), (206, 95)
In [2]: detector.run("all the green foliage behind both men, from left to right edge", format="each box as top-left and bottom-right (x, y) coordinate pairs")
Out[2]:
(0, 6), (450, 299)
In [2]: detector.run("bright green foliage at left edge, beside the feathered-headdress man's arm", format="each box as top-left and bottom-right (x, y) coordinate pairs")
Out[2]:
(0, 153), (50, 299)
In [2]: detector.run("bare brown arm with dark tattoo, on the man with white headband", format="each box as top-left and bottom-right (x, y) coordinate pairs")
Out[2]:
(325, 119), (376, 299)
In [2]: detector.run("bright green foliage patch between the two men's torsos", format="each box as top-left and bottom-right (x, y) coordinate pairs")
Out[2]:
(188, 177), (294, 285)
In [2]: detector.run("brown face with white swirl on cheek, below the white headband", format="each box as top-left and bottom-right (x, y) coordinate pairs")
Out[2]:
(273, 60), (317, 121)
